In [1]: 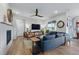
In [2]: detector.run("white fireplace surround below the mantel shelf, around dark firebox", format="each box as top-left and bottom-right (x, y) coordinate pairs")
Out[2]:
(0, 23), (13, 55)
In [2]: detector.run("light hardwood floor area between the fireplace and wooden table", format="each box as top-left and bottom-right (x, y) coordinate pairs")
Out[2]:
(7, 37), (32, 55)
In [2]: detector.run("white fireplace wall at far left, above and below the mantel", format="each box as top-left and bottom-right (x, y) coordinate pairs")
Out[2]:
(0, 3), (13, 55)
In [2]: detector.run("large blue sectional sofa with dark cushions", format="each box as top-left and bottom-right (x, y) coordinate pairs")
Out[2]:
(41, 32), (65, 51)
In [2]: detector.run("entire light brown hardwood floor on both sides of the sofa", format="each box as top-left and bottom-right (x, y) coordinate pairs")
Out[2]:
(7, 38), (79, 55)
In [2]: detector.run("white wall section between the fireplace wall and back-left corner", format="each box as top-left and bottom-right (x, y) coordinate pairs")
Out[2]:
(13, 14), (24, 38)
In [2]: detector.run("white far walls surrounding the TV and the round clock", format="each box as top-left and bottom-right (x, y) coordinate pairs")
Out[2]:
(14, 13), (67, 36)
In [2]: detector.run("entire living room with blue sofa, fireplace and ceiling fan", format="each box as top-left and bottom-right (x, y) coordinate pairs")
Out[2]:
(0, 3), (79, 55)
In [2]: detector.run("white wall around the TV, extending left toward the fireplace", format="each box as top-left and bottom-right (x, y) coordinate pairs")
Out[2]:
(13, 14), (47, 36)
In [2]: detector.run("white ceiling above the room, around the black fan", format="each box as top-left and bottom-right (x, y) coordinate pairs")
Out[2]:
(9, 3), (79, 18)
